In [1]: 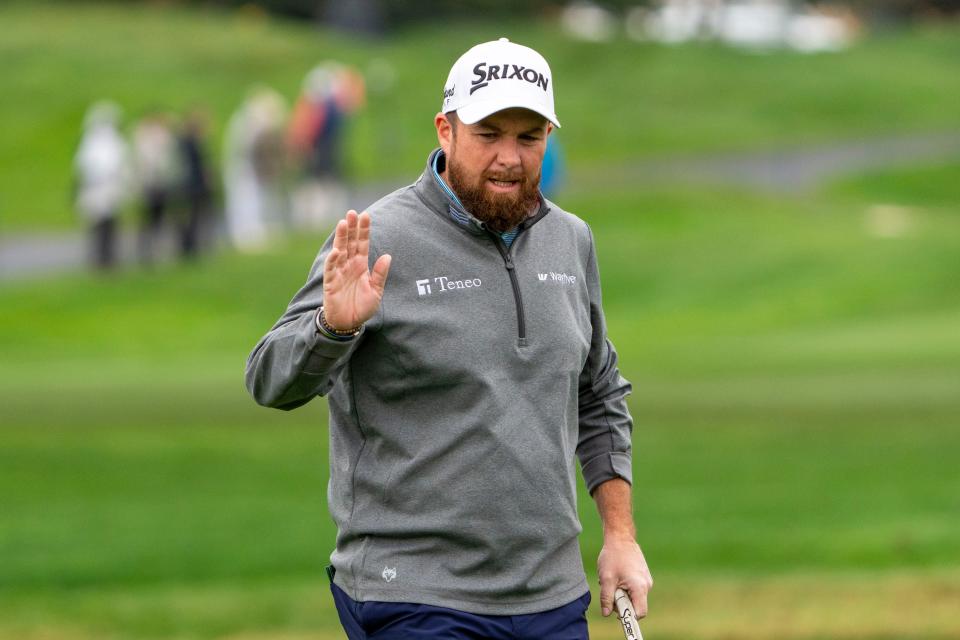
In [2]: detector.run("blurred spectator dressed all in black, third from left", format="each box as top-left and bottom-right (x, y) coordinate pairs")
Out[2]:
(179, 109), (213, 259)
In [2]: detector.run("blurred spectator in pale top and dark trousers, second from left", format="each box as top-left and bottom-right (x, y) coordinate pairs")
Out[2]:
(133, 112), (178, 265)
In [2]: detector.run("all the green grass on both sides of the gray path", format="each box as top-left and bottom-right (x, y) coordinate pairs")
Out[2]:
(0, 2), (960, 640)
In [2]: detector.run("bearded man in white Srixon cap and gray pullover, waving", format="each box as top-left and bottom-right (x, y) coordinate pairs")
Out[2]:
(247, 39), (652, 640)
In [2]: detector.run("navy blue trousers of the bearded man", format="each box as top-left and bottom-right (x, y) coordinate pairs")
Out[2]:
(330, 583), (590, 640)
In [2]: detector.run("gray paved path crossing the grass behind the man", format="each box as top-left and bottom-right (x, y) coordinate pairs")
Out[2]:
(0, 131), (960, 281)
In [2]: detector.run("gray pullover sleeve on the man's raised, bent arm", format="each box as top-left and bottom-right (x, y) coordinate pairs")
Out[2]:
(246, 235), (366, 410)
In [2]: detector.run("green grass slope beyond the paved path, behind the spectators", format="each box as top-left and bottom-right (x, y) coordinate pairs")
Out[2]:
(0, 2), (960, 231)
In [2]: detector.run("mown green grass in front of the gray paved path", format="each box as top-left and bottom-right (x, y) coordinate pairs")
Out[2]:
(0, 159), (960, 640)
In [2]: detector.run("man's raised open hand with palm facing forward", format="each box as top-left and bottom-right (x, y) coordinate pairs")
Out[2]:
(323, 209), (391, 331)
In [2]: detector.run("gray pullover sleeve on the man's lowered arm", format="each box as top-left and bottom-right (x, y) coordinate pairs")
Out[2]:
(577, 226), (633, 493)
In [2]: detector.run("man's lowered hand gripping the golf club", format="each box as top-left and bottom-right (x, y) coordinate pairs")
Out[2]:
(597, 538), (653, 618)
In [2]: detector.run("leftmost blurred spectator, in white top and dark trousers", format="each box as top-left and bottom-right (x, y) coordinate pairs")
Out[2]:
(74, 102), (130, 269)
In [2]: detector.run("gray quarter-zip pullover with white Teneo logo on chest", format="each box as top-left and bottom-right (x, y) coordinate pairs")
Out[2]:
(246, 150), (632, 615)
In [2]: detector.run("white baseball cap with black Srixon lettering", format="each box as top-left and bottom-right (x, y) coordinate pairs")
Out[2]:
(440, 38), (560, 127)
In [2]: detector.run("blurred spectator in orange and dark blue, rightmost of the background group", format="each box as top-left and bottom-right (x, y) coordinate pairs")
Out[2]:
(287, 62), (365, 228)
